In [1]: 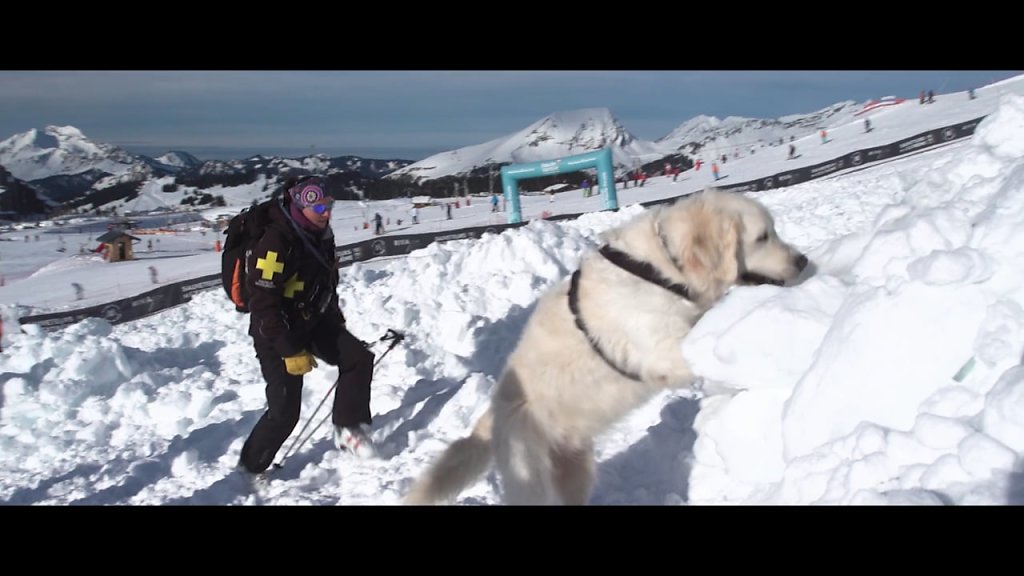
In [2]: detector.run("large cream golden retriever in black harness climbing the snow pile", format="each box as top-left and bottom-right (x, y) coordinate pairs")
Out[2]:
(404, 190), (807, 504)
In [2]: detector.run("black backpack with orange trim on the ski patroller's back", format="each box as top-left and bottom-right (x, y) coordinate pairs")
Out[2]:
(220, 200), (274, 314)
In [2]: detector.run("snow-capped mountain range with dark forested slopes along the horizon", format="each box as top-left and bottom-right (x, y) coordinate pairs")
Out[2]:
(0, 100), (861, 217)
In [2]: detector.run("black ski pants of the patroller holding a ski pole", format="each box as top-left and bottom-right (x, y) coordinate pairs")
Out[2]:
(241, 325), (374, 474)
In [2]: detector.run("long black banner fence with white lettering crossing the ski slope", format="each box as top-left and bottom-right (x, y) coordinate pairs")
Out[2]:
(18, 117), (984, 330)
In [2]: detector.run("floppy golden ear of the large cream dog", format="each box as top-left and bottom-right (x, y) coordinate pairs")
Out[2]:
(683, 204), (742, 292)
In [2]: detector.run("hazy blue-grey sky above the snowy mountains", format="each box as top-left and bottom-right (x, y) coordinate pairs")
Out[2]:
(0, 71), (1020, 160)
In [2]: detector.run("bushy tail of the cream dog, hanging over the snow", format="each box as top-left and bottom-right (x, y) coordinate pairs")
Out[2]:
(404, 408), (495, 504)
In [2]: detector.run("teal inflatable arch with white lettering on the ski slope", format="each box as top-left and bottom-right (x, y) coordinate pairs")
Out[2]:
(502, 148), (618, 224)
